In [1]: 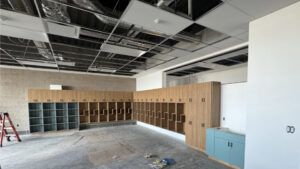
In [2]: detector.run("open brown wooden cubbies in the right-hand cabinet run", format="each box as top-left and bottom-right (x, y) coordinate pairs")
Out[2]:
(133, 102), (185, 134)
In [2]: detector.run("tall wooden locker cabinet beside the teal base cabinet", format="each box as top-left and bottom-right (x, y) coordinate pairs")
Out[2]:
(186, 82), (221, 151)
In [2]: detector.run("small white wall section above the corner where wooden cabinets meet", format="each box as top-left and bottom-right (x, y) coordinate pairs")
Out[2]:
(136, 71), (166, 91)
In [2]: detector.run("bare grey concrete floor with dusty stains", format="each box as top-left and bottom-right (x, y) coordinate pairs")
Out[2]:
(0, 125), (230, 169)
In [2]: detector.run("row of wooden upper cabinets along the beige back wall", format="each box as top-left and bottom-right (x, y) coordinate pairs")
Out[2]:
(28, 89), (133, 102)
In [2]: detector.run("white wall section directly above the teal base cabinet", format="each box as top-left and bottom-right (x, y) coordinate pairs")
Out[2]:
(221, 82), (247, 134)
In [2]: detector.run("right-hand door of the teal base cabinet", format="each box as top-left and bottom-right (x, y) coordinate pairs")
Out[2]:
(229, 141), (245, 168)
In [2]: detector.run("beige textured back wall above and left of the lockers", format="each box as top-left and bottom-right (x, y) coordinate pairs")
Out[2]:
(0, 68), (136, 131)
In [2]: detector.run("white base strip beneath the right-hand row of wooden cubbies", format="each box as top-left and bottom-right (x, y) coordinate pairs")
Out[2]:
(136, 121), (185, 142)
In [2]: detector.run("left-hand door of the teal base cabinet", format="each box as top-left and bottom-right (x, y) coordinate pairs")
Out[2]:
(215, 137), (230, 162)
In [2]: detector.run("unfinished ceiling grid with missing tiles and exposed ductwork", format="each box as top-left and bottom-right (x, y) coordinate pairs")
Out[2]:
(0, 0), (297, 76)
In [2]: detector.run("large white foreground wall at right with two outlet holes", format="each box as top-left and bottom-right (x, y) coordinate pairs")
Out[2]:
(245, 2), (300, 169)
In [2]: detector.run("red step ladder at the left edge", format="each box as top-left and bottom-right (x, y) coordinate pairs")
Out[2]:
(0, 113), (21, 147)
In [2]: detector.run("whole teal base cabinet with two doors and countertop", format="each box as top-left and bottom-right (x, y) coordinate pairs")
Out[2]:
(206, 128), (245, 168)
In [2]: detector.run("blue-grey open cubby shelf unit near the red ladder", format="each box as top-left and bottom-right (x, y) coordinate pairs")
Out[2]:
(28, 102), (79, 133)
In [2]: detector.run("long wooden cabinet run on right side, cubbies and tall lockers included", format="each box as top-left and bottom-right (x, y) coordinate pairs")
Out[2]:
(133, 82), (221, 151)
